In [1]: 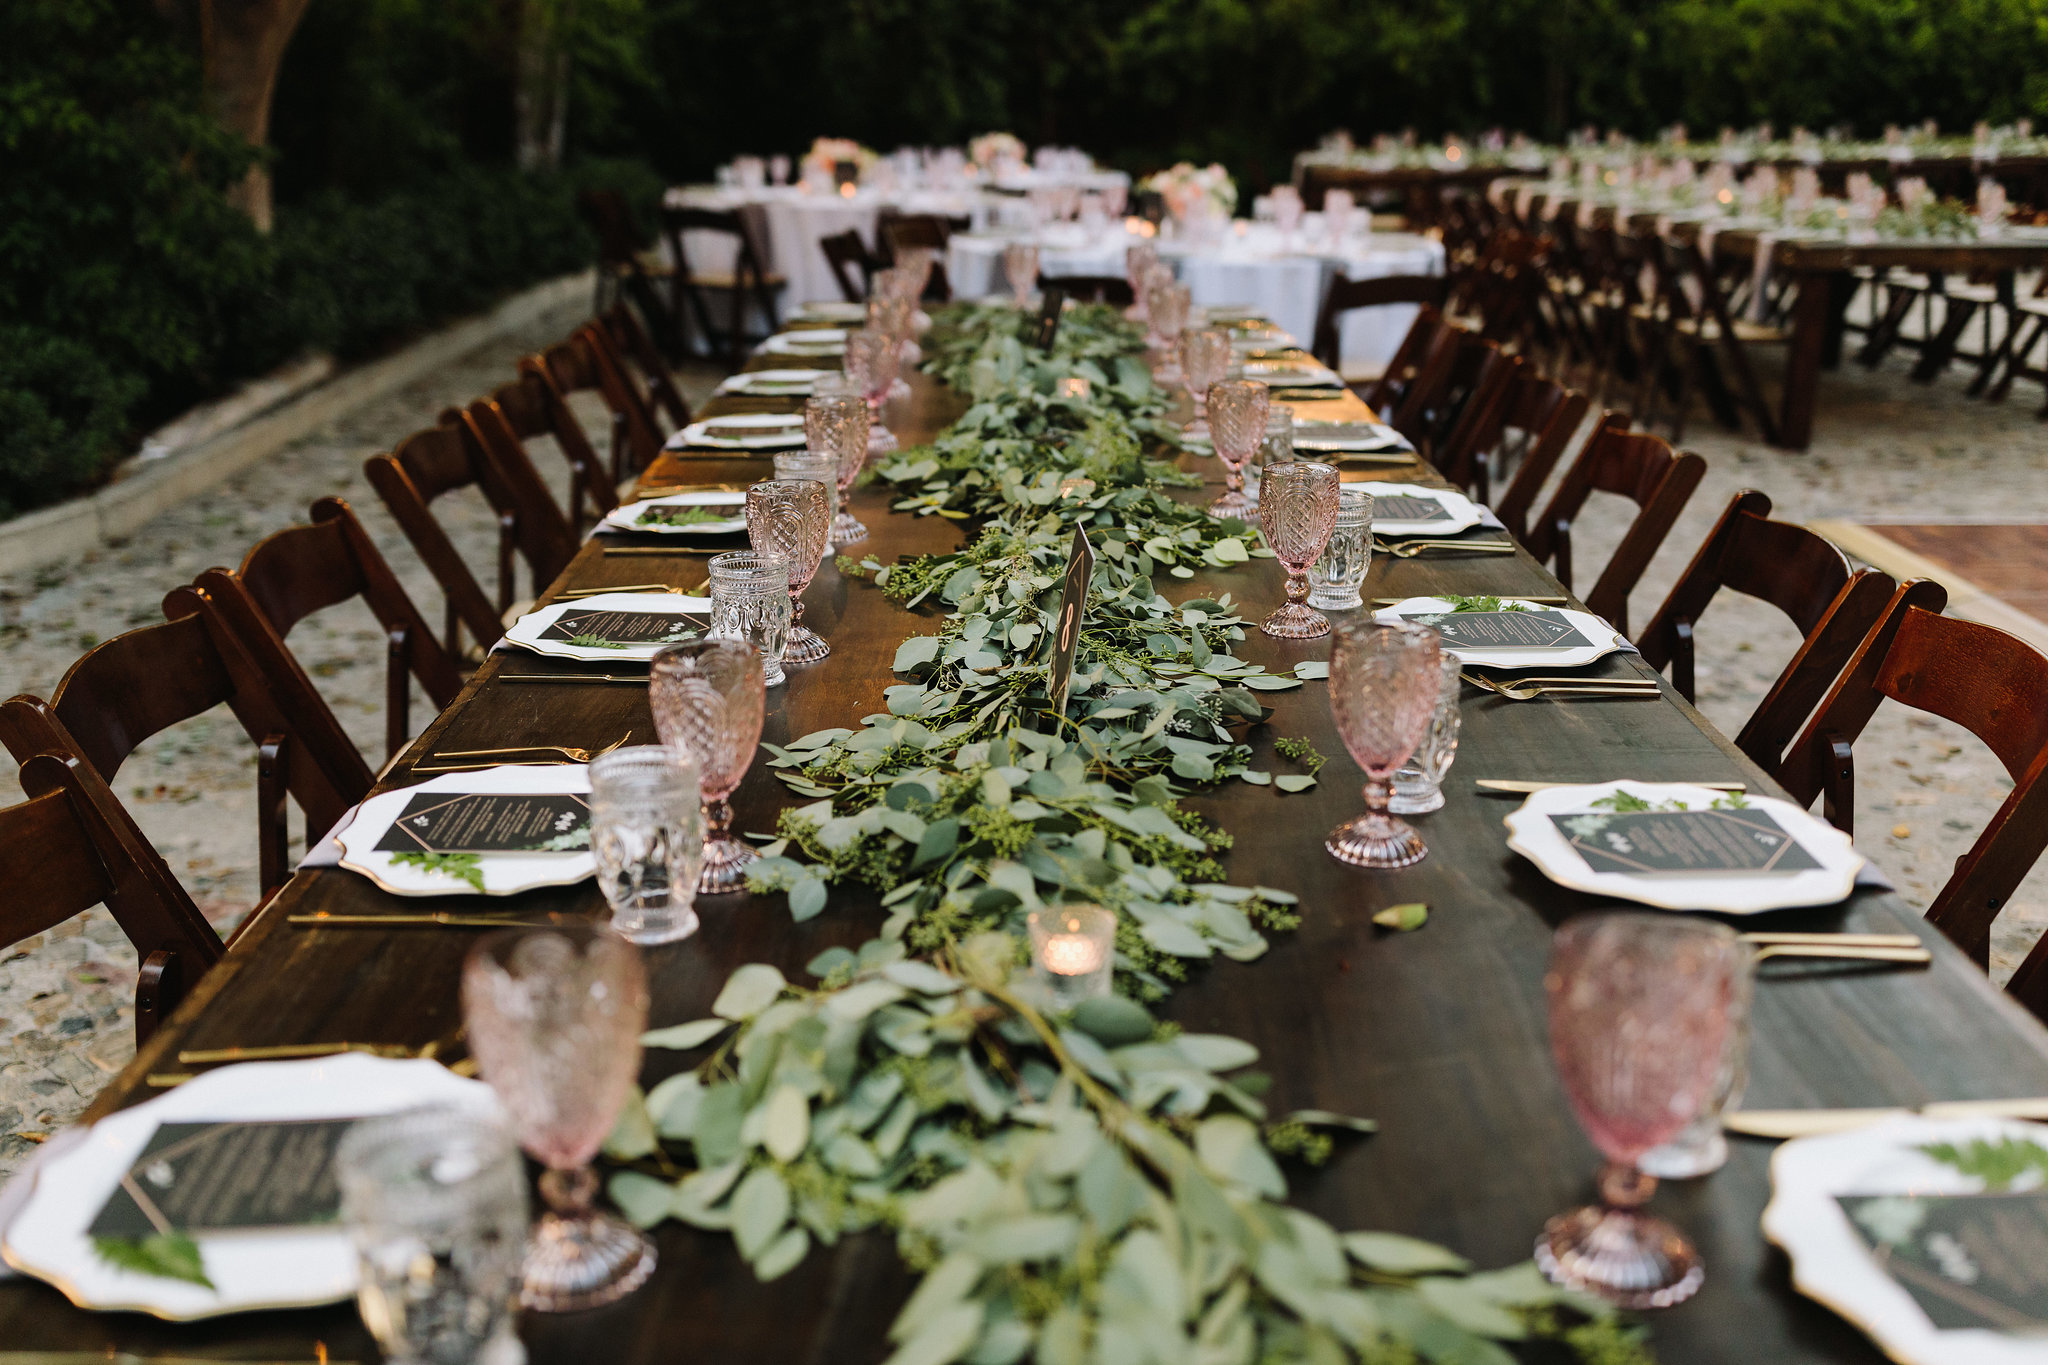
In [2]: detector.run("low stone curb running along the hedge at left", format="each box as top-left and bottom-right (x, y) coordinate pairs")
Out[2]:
(0, 270), (594, 573)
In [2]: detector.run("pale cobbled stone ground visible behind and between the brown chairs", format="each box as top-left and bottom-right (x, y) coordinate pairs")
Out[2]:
(0, 311), (2048, 1175)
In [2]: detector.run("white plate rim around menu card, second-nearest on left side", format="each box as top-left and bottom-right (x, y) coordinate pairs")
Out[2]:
(334, 763), (598, 896)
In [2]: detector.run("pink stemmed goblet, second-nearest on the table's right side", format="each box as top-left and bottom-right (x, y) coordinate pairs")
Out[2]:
(1327, 618), (1444, 868)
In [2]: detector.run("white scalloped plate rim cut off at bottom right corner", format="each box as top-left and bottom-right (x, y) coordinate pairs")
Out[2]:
(1763, 1117), (2048, 1365)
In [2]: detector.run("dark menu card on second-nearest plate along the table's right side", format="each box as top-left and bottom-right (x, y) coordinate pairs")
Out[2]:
(1550, 808), (1821, 876)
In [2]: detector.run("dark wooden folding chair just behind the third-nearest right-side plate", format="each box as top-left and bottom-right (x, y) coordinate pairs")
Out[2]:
(1528, 411), (1706, 634)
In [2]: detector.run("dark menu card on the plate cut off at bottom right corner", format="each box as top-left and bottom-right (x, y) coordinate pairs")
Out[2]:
(1835, 1189), (2048, 1336)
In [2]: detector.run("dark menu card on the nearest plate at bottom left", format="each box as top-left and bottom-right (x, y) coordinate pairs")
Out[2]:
(88, 1119), (354, 1238)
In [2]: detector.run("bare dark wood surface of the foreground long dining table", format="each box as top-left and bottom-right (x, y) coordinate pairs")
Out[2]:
(0, 343), (2048, 1365)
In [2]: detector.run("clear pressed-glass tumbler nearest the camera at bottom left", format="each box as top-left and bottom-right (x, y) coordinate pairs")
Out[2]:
(334, 1105), (528, 1365)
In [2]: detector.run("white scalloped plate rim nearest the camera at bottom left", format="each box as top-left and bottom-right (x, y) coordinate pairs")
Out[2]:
(0, 1052), (498, 1322)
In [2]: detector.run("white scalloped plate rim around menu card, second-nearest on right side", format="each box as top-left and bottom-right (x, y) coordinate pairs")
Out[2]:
(1505, 782), (1866, 915)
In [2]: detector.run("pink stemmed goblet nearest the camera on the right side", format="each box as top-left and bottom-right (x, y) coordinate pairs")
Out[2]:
(1536, 913), (1751, 1308)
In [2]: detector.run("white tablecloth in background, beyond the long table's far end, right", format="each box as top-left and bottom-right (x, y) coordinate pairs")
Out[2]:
(946, 221), (1444, 375)
